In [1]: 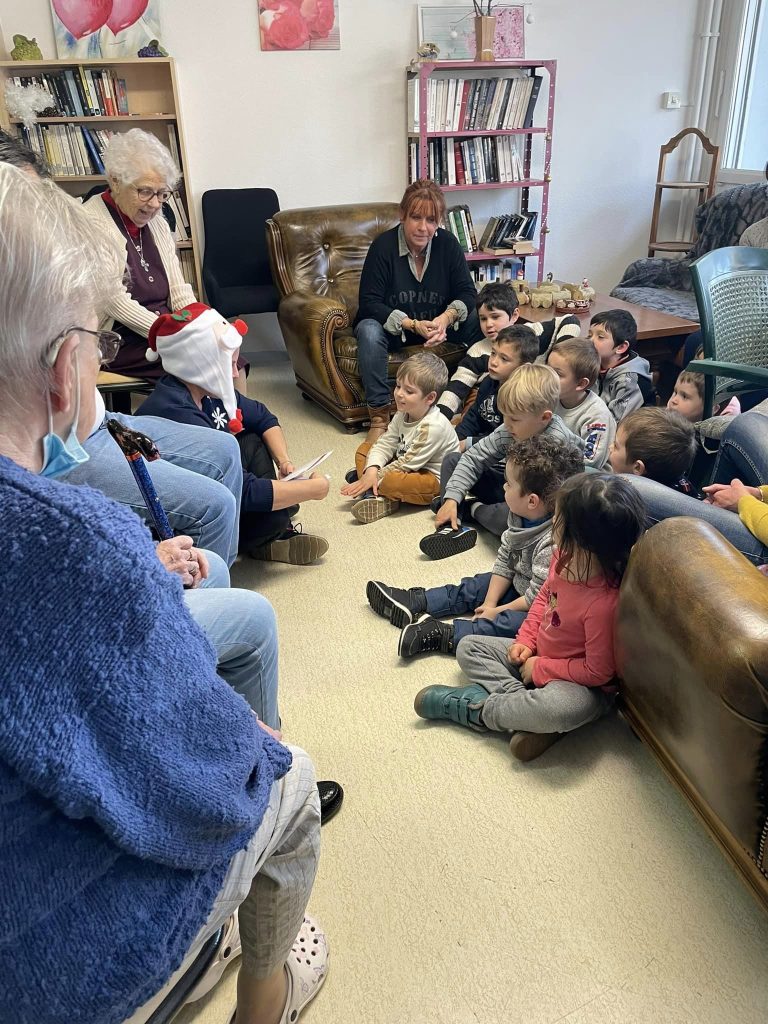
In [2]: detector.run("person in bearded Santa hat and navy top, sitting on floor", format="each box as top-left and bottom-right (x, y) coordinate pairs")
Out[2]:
(136, 302), (329, 565)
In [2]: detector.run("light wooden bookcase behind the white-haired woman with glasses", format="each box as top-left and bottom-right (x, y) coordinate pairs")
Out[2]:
(0, 57), (202, 297)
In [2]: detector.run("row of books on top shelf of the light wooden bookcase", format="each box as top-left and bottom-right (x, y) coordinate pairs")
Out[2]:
(13, 68), (128, 118)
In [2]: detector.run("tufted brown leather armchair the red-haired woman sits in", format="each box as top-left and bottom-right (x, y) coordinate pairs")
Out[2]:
(266, 203), (465, 433)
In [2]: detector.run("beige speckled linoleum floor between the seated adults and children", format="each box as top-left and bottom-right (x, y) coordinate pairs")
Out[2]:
(180, 362), (768, 1024)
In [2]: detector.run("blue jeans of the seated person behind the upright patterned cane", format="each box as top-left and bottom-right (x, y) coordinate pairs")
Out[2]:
(61, 413), (243, 565)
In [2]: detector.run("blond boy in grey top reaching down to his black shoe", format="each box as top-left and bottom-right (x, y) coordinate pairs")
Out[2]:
(419, 362), (584, 558)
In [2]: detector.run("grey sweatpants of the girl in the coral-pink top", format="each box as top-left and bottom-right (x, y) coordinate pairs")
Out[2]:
(456, 636), (613, 732)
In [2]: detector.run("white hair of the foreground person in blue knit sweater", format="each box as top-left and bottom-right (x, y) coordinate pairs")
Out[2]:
(0, 163), (115, 418)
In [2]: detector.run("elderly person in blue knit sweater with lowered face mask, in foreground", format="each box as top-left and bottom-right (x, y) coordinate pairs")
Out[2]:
(0, 165), (328, 1024)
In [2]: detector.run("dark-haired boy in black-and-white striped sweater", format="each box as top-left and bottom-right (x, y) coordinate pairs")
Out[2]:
(437, 282), (581, 420)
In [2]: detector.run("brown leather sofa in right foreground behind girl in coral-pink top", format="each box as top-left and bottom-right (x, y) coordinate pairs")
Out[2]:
(616, 518), (768, 909)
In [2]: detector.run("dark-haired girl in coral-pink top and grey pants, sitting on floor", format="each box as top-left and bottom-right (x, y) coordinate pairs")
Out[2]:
(414, 473), (645, 761)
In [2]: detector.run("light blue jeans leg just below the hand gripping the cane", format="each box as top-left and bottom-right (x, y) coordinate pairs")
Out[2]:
(184, 551), (280, 738)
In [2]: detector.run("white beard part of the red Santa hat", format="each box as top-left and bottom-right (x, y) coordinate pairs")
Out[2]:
(149, 309), (243, 420)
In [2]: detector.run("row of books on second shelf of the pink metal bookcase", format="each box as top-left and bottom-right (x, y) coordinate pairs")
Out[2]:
(409, 135), (525, 185)
